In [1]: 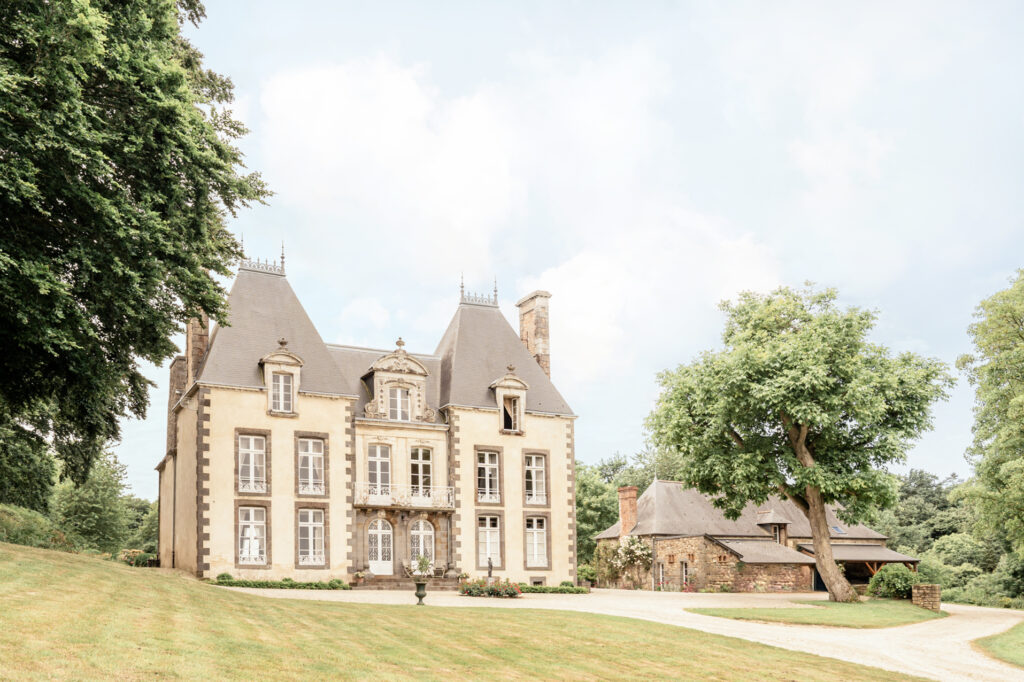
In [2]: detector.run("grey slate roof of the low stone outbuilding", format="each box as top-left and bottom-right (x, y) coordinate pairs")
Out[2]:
(596, 480), (885, 540)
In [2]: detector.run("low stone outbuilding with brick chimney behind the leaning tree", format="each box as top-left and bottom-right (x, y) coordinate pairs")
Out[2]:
(596, 480), (918, 592)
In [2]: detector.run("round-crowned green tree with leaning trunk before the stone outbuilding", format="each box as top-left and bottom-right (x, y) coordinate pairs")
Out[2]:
(648, 288), (952, 601)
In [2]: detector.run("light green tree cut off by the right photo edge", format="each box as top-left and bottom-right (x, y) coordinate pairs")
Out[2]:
(957, 270), (1024, 558)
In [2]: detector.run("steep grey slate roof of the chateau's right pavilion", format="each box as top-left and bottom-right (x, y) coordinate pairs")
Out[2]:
(434, 302), (572, 415)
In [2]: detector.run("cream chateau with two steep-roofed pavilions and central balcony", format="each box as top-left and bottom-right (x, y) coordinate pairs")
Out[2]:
(157, 261), (577, 585)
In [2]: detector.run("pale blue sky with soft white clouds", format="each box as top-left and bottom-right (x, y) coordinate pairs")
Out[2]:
(116, 0), (1024, 499)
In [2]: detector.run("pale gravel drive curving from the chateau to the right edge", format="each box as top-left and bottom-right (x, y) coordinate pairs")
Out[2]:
(229, 588), (1024, 682)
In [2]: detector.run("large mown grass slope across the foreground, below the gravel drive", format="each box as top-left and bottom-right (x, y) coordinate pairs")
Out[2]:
(0, 544), (925, 681)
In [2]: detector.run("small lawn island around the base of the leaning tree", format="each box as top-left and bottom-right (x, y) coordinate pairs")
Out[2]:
(686, 599), (946, 628)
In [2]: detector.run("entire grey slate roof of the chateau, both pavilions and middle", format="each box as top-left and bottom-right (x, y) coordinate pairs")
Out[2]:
(199, 265), (572, 415)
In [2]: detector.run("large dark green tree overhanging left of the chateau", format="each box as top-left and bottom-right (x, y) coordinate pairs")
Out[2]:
(0, 0), (267, 491)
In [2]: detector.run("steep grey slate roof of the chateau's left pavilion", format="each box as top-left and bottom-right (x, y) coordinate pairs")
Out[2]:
(199, 267), (354, 395)
